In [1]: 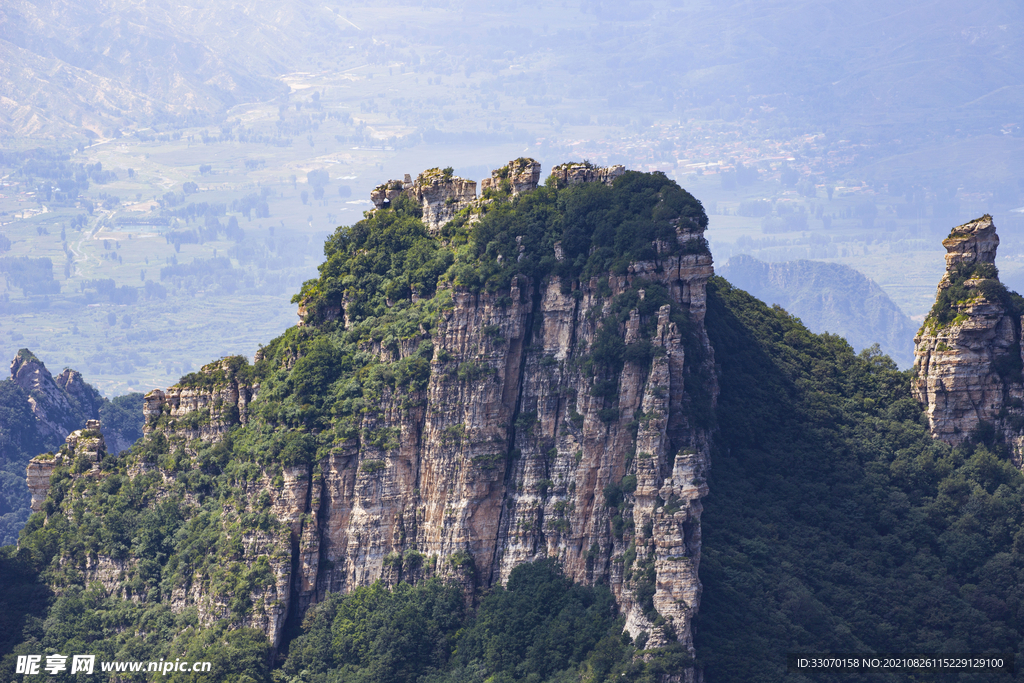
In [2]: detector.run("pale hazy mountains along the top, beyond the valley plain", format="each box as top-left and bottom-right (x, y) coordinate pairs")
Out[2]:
(0, 0), (1024, 163)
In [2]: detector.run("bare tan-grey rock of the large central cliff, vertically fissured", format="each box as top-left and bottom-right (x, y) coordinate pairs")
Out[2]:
(24, 160), (718, 679)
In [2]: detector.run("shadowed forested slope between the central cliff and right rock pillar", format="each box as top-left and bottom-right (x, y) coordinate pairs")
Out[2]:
(694, 279), (1024, 682)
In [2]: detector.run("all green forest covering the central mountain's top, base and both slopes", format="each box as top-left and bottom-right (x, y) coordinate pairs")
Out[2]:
(0, 173), (1024, 683)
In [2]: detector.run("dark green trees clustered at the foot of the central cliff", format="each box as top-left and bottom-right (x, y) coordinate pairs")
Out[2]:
(284, 560), (688, 683)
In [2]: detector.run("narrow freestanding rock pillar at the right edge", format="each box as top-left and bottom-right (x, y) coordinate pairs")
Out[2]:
(913, 215), (1024, 460)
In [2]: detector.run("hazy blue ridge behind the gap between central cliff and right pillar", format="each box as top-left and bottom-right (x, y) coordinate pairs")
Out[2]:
(716, 256), (920, 370)
